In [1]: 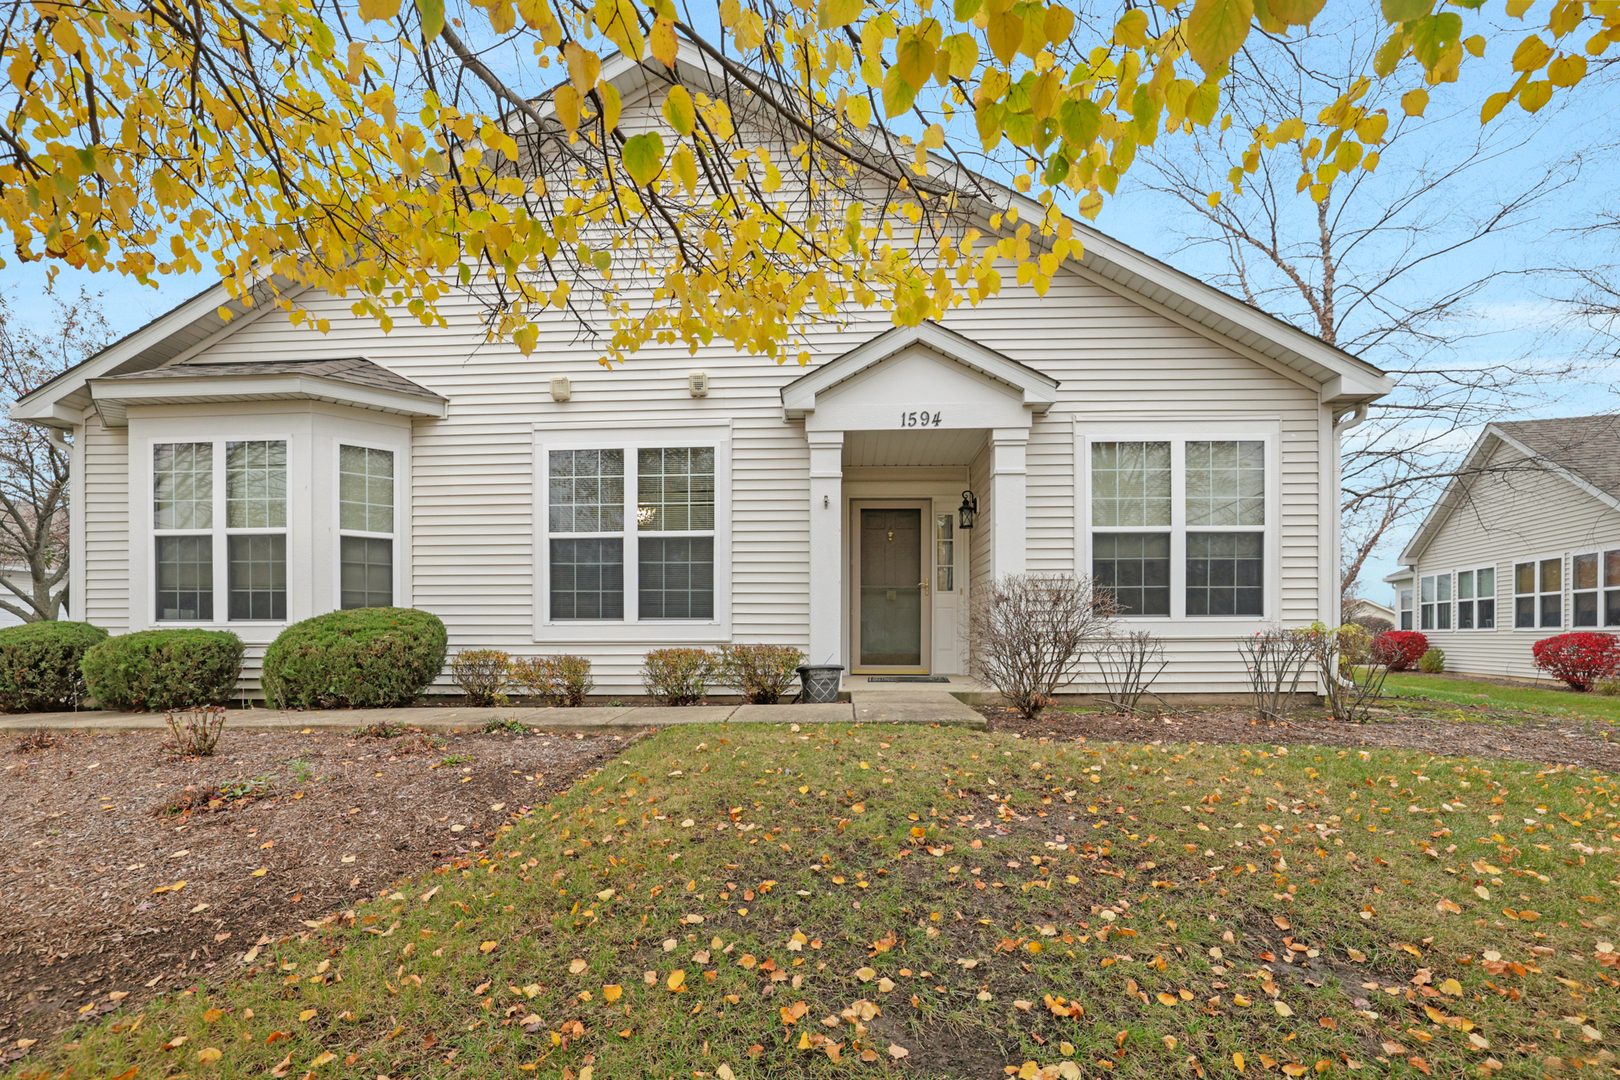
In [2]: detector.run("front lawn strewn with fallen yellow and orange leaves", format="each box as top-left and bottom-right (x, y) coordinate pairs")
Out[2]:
(16, 725), (1620, 1080)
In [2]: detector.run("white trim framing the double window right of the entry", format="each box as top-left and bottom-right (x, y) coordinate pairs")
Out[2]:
(1074, 419), (1283, 638)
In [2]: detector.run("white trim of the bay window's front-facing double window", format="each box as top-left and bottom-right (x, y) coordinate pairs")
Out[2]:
(147, 431), (293, 636)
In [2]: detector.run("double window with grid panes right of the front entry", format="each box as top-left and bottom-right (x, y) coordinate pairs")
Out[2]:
(1090, 439), (1267, 619)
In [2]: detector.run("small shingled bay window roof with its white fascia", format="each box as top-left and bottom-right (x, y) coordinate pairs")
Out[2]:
(89, 356), (446, 427)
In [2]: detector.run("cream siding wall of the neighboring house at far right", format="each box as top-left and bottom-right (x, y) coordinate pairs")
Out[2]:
(1413, 442), (1620, 678)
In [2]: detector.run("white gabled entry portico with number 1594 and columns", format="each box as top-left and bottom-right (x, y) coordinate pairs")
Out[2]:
(782, 322), (1058, 674)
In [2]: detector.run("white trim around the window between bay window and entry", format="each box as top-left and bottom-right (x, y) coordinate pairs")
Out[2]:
(533, 421), (732, 644)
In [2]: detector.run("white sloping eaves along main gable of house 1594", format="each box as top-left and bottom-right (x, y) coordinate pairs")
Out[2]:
(11, 49), (1395, 427)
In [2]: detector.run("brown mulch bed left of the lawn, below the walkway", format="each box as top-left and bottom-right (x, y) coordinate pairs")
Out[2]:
(0, 729), (630, 1065)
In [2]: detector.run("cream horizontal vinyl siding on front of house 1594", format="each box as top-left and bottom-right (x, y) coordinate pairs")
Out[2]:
(86, 246), (1333, 693)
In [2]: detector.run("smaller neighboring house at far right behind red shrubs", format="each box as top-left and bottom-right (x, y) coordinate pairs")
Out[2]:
(1385, 415), (1620, 678)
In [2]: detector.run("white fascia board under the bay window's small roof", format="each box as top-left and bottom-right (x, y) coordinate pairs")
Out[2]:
(89, 376), (446, 427)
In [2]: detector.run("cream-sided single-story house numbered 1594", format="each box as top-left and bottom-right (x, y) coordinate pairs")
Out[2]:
(3, 50), (1392, 695)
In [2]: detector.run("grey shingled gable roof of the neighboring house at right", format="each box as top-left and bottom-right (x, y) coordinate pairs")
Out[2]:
(1385, 413), (1620, 566)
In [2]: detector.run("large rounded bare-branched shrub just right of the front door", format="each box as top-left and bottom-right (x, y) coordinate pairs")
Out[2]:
(967, 573), (1119, 719)
